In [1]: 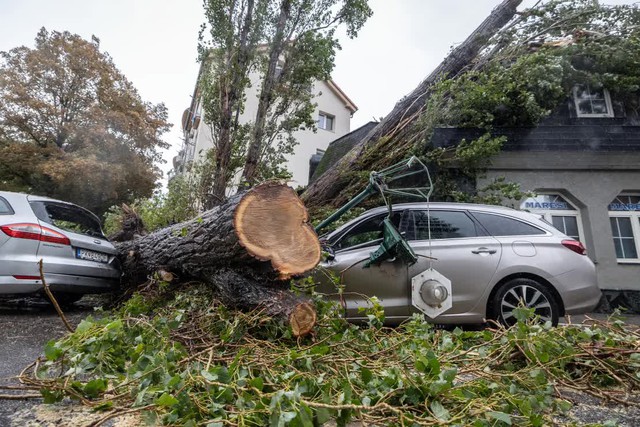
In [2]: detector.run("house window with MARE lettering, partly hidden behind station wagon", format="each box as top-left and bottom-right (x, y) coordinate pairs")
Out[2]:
(520, 194), (584, 241)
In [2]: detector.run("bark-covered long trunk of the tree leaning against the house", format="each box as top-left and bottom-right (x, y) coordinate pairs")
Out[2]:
(302, 0), (522, 206)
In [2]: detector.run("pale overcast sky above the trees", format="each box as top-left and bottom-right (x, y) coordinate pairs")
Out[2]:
(0, 0), (634, 181)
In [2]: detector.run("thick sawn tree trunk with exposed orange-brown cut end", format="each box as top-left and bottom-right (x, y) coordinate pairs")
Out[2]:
(116, 183), (321, 335)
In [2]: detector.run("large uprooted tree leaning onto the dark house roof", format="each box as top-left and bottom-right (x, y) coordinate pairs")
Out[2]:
(303, 0), (640, 208)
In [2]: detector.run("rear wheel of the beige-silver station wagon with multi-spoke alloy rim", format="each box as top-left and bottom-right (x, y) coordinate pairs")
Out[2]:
(490, 278), (560, 326)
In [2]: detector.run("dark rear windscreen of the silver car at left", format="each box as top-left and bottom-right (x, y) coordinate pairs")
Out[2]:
(31, 202), (104, 238)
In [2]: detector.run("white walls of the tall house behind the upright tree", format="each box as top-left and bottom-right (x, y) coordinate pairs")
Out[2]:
(182, 73), (355, 187)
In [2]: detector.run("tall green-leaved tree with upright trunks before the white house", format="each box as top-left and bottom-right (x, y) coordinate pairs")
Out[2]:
(199, 0), (372, 206)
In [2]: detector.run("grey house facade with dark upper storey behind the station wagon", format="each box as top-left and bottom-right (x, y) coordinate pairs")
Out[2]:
(431, 86), (640, 300)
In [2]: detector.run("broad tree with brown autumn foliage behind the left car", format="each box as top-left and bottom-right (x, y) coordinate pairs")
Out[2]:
(0, 28), (170, 214)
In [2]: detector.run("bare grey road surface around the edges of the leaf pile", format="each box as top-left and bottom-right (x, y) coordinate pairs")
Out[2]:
(0, 296), (640, 427)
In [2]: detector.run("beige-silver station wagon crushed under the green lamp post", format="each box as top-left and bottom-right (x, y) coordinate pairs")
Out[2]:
(316, 203), (601, 325)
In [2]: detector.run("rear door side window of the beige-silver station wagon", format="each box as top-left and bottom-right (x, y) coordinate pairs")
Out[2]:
(407, 211), (478, 240)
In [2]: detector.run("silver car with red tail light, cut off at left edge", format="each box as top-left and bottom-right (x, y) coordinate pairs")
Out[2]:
(0, 191), (120, 304)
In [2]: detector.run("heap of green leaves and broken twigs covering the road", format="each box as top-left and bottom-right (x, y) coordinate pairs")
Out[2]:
(22, 282), (640, 426)
